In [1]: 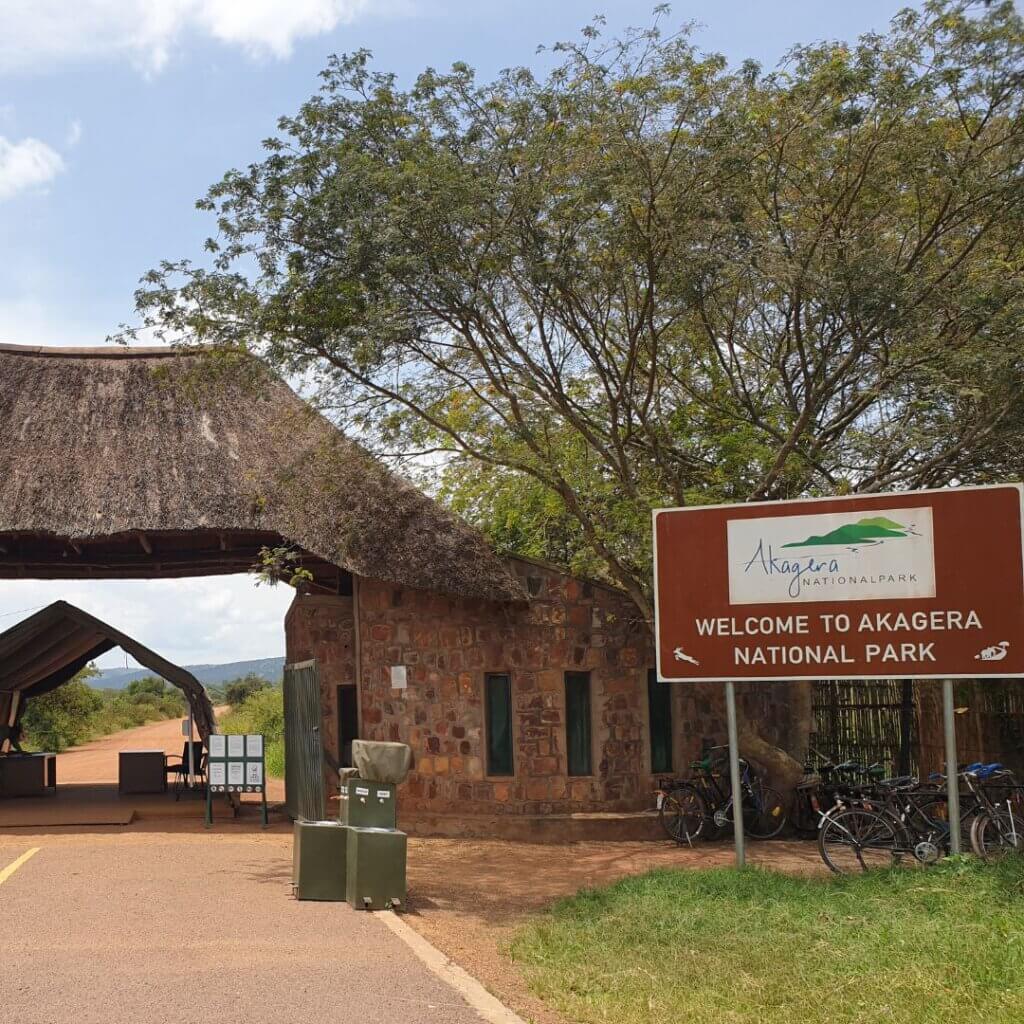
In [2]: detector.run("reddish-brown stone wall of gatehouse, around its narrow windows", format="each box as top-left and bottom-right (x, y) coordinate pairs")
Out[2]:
(286, 559), (784, 815)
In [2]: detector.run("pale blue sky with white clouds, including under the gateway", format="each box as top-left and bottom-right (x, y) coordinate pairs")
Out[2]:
(0, 0), (921, 667)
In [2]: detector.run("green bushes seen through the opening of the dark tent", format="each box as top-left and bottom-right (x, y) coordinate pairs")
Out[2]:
(22, 665), (188, 753)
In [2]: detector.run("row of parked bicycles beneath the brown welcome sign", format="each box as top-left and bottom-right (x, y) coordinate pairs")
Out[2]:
(657, 748), (1024, 873)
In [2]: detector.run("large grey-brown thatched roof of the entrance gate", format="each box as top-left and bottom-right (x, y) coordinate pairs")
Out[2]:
(0, 345), (524, 600)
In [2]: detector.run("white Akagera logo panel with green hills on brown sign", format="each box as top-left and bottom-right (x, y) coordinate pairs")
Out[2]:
(727, 508), (935, 604)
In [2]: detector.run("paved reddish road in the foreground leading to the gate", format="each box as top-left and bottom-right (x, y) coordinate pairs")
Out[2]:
(0, 833), (479, 1024)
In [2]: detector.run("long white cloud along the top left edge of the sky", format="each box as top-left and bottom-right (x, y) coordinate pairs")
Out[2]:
(0, 0), (370, 73)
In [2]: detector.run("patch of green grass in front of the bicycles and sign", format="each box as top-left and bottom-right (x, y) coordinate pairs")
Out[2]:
(510, 858), (1024, 1024)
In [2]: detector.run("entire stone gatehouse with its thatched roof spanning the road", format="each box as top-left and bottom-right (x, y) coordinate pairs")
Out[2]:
(0, 346), (753, 835)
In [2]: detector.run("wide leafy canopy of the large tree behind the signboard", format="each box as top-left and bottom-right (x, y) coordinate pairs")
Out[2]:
(132, 0), (1024, 614)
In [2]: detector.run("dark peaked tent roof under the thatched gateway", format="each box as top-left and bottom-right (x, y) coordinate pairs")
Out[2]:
(0, 601), (216, 739)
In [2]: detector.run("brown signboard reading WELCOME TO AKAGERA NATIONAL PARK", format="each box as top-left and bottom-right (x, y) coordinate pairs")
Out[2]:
(654, 484), (1024, 682)
